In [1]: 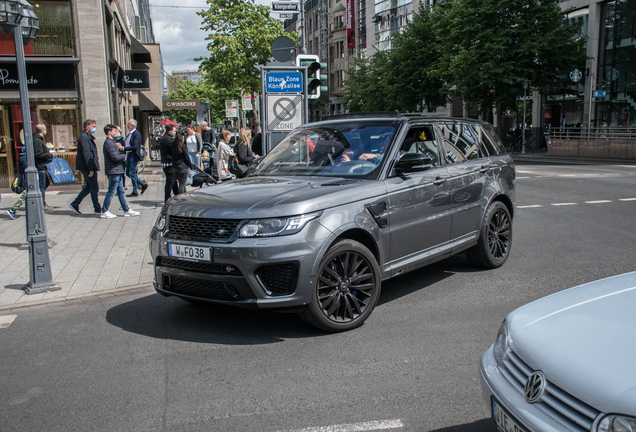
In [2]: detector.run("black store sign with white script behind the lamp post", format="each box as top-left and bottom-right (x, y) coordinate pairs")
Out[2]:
(0, 63), (75, 91)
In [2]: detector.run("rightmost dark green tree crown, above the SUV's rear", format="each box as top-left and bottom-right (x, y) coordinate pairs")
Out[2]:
(431, 0), (586, 112)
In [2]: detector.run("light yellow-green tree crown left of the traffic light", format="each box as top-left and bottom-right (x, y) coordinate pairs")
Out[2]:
(198, 0), (296, 93)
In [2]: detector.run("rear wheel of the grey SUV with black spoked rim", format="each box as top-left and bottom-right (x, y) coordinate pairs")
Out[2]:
(466, 201), (512, 269)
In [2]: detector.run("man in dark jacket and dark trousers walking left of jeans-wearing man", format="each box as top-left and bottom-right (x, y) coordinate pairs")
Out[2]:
(69, 119), (102, 216)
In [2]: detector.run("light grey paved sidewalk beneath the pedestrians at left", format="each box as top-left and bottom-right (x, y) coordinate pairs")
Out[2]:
(0, 162), (164, 310)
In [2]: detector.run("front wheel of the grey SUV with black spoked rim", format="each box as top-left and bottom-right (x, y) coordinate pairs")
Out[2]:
(299, 239), (381, 332)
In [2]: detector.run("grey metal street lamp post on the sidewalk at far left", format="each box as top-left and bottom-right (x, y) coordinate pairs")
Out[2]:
(0, 0), (60, 294)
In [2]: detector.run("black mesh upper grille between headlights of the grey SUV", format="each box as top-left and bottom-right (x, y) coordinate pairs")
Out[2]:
(165, 216), (241, 241)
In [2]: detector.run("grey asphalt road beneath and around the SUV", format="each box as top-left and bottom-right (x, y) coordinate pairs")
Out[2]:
(0, 160), (636, 432)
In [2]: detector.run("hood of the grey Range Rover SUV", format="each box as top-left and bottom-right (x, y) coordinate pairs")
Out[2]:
(163, 177), (386, 219)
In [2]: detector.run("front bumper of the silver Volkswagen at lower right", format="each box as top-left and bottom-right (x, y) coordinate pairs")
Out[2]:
(479, 345), (601, 432)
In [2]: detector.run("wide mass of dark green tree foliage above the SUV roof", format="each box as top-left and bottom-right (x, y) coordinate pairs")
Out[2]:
(342, 0), (586, 112)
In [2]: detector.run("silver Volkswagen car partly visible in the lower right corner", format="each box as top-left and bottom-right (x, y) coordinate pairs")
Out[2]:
(480, 272), (636, 432)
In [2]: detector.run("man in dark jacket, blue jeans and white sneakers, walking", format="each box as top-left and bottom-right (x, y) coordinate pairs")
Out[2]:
(99, 124), (139, 219)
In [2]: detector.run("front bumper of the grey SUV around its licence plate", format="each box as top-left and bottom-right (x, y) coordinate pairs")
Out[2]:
(150, 221), (333, 309)
